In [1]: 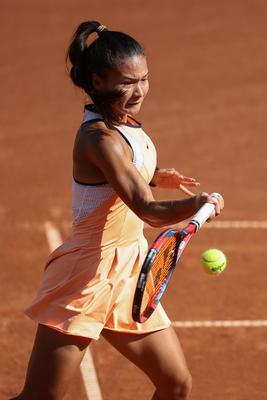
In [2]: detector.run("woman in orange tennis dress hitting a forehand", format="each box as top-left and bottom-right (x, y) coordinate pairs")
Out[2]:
(13, 21), (223, 400)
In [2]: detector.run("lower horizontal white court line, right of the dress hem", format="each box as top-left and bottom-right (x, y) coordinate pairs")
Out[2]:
(172, 319), (267, 328)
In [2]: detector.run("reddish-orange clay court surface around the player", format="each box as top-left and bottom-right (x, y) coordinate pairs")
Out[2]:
(0, 0), (267, 400)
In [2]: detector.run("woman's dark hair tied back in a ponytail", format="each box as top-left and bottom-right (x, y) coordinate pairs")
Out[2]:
(66, 21), (145, 125)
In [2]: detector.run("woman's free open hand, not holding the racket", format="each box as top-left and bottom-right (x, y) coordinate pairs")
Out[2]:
(152, 168), (200, 196)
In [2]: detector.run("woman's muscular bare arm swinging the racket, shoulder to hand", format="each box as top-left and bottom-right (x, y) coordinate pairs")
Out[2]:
(78, 130), (223, 227)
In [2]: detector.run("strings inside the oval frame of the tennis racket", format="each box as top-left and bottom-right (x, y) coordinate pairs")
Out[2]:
(141, 235), (177, 312)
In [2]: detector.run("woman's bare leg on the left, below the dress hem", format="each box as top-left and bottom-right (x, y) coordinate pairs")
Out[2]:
(15, 325), (90, 400)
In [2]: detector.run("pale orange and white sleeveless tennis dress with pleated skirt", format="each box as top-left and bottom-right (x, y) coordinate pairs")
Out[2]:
(25, 107), (170, 339)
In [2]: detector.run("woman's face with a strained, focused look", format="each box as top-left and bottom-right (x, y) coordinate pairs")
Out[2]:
(92, 55), (149, 121)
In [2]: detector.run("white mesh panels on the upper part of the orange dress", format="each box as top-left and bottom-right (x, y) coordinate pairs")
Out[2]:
(72, 110), (144, 224)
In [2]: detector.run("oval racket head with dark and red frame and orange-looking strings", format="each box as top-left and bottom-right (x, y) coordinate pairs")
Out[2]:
(132, 229), (181, 323)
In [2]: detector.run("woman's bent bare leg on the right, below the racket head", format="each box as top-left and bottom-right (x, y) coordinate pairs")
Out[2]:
(102, 328), (192, 400)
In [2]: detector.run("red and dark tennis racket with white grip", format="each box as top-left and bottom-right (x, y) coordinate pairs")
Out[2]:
(132, 203), (217, 323)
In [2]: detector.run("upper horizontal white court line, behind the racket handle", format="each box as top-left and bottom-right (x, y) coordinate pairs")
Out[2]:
(145, 220), (267, 229)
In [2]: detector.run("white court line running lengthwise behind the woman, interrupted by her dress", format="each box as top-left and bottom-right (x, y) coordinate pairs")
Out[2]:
(45, 221), (102, 400)
